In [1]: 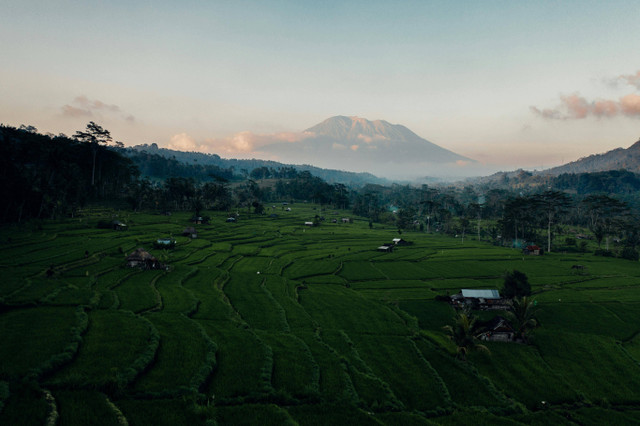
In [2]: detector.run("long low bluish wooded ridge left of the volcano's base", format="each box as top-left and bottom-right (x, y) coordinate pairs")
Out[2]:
(124, 143), (390, 186)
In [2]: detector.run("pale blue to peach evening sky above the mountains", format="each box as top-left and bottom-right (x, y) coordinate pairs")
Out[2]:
(0, 0), (640, 176)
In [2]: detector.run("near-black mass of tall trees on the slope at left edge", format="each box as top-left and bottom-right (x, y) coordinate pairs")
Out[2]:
(0, 122), (138, 222)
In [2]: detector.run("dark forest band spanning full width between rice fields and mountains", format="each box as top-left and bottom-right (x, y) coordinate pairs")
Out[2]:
(0, 122), (640, 257)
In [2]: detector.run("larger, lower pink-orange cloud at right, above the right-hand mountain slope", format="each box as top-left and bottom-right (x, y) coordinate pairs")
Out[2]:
(529, 93), (640, 120)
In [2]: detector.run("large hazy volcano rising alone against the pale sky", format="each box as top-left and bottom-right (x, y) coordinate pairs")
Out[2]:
(261, 116), (475, 177)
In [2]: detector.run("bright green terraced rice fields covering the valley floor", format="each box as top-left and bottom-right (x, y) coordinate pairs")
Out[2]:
(0, 203), (640, 425)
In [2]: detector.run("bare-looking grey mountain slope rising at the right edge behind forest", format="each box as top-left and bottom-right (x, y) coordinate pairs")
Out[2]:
(541, 140), (640, 176)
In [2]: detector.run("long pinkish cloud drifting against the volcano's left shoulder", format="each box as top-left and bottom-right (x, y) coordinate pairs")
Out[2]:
(167, 131), (314, 155)
